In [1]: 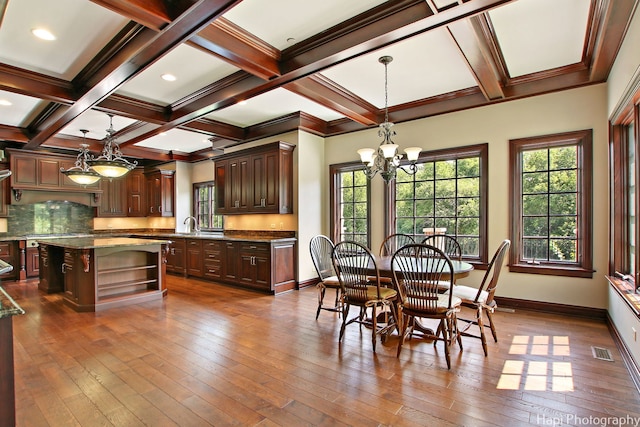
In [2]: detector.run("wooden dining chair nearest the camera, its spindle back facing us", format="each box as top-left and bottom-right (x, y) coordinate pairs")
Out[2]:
(391, 244), (462, 369)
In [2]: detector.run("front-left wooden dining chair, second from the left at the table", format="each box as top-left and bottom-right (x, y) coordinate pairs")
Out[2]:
(332, 241), (397, 353)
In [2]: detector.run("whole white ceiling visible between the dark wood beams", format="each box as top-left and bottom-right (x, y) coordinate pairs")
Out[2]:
(0, 0), (604, 153)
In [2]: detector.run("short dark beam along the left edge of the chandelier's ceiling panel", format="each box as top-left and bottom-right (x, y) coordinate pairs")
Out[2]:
(284, 74), (378, 126)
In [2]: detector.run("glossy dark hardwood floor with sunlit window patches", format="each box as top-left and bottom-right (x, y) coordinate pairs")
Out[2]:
(3, 276), (640, 427)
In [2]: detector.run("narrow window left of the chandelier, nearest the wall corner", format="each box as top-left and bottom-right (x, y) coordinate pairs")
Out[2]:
(330, 163), (370, 247)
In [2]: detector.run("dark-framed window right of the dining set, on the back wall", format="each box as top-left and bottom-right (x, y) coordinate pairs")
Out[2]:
(510, 130), (593, 277)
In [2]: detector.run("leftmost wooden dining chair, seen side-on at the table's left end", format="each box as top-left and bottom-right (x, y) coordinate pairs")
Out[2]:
(309, 234), (342, 320)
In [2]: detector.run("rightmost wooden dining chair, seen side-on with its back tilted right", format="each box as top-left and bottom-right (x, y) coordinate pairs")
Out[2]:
(452, 239), (511, 357)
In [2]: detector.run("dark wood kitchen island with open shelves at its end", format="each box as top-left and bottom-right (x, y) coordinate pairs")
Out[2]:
(38, 236), (170, 311)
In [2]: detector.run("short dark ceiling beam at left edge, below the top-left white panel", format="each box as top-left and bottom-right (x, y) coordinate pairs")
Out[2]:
(0, 64), (75, 104)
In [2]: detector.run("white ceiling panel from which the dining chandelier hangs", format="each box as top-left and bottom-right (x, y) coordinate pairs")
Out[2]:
(322, 29), (477, 108)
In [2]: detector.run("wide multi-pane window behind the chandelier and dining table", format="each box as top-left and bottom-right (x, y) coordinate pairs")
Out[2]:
(388, 144), (488, 264)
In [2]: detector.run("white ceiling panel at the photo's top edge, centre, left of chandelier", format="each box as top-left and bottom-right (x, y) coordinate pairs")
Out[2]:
(224, 0), (384, 50)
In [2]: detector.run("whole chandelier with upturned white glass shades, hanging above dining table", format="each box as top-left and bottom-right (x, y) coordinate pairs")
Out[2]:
(357, 56), (422, 183)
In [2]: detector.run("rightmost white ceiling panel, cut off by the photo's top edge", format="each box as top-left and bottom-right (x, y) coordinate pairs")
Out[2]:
(489, 0), (591, 77)
